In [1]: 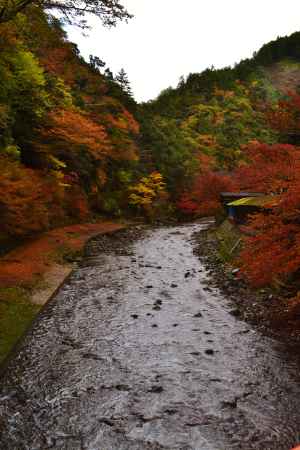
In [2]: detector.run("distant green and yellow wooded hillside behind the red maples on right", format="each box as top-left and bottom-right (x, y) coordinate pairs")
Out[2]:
(140, 32), (300, 207)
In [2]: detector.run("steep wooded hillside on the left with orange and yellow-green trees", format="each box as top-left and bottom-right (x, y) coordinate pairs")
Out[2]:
(0, 7), (145, 246)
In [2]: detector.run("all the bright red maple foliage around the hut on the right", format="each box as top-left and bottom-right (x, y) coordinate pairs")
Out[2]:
(177, 87), (300, 293)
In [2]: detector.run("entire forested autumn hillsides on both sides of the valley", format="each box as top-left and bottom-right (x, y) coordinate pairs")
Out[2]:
(0, 5), (300, 298)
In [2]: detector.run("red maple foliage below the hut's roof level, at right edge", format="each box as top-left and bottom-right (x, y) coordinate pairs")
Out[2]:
(240, 202), (300, 287)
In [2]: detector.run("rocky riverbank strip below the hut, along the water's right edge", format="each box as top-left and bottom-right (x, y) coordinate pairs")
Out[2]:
(194, 226), (300, 342)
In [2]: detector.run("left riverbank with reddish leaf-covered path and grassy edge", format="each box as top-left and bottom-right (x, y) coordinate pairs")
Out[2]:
(0, 221), (126, 363)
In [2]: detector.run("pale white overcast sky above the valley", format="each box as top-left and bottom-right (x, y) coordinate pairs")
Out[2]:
(68, 0), (300, 101)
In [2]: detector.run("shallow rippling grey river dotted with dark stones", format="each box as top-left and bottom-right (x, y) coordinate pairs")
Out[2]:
(0, 223), (300, 450)
